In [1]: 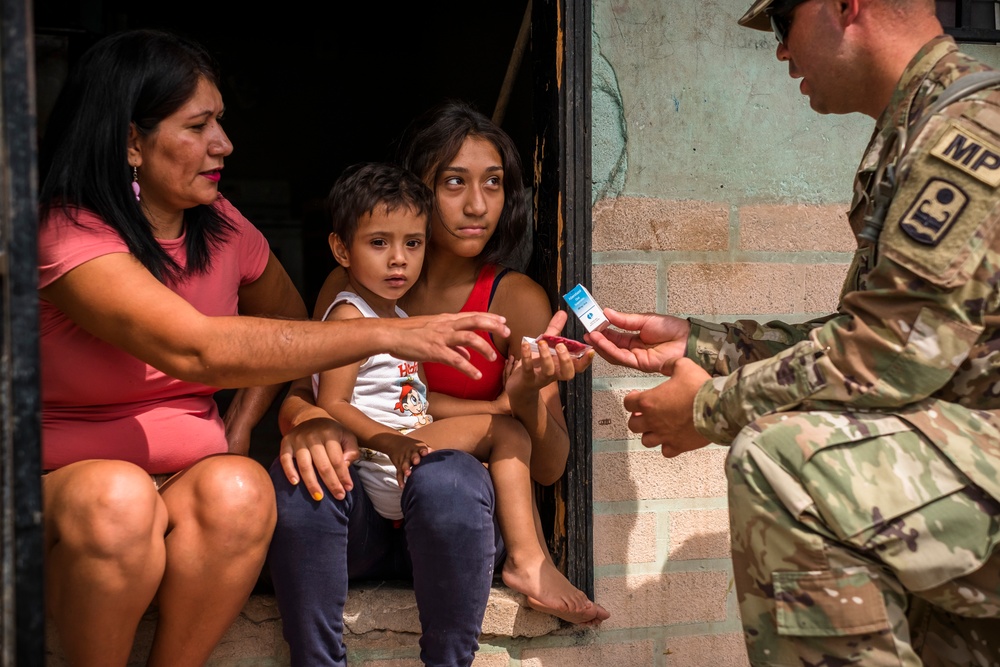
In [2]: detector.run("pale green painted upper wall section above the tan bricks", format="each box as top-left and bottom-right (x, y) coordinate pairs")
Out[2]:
(592, 0), (1000, 204)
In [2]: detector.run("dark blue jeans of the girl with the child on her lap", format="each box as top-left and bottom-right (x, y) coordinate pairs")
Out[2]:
(268, 450), (504, 667)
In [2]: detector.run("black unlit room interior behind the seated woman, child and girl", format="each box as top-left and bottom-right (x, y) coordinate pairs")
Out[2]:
(33, 0), (534, 309)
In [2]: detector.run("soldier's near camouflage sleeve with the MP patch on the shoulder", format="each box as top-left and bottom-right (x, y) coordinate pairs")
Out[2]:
(694, 103), (1000, 443)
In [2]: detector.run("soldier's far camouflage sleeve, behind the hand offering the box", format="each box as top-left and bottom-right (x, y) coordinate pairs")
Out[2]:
(686, 318), (828, 375)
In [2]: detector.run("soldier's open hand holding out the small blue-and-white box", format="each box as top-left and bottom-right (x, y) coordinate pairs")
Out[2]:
(584, 308), (691, 375)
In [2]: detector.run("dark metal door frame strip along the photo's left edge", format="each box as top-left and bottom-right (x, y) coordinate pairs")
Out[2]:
(0, 0), (45, 667)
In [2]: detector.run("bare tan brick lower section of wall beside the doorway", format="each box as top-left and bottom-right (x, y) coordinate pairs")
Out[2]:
(584, 197), (855, 667)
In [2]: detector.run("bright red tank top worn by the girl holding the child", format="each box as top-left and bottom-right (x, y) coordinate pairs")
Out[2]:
(424, 264), (508, 401)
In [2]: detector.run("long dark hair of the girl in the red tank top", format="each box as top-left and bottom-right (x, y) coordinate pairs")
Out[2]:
(397, 99), (529, 264)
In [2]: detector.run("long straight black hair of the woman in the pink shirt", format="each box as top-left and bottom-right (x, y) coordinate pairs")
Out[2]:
(39, 30), (234, 282)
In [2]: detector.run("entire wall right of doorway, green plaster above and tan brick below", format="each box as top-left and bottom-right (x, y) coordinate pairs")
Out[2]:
(588, 0), (873, 656)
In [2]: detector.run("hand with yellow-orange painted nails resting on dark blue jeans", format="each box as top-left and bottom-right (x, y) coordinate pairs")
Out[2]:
(278, 417), (360, 500)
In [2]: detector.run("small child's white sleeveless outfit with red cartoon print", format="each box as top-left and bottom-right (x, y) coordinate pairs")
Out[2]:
(312, 291), (431, 520)
